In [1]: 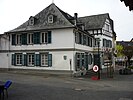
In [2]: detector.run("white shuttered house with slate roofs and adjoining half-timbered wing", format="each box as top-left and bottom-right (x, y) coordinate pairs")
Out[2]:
(0, 3), (116, 76)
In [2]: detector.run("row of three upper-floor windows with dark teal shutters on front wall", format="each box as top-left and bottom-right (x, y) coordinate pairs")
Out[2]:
(11, 31), (52, 45)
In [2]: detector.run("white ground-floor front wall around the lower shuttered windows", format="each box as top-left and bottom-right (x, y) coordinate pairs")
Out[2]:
(10, 51), (74, 71)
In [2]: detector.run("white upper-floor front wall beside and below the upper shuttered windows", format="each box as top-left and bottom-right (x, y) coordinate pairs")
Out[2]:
(10, 28), (74, 50)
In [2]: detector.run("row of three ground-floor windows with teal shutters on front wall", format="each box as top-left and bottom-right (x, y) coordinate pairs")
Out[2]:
(11, 53), (52, 67)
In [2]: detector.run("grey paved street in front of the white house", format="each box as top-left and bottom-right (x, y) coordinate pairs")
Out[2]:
(0, 72), (133, 100)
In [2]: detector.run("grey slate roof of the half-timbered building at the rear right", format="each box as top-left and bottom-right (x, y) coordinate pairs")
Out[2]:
(78, 13), (109, 30)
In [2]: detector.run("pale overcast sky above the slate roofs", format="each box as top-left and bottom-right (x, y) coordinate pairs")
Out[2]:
(0, 0), (133, 41)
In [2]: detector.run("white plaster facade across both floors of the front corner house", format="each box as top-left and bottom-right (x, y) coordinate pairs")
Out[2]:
(0, 28), (93, 72)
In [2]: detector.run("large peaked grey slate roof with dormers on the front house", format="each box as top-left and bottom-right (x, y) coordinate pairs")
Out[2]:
(9, 3), (74, 33)
